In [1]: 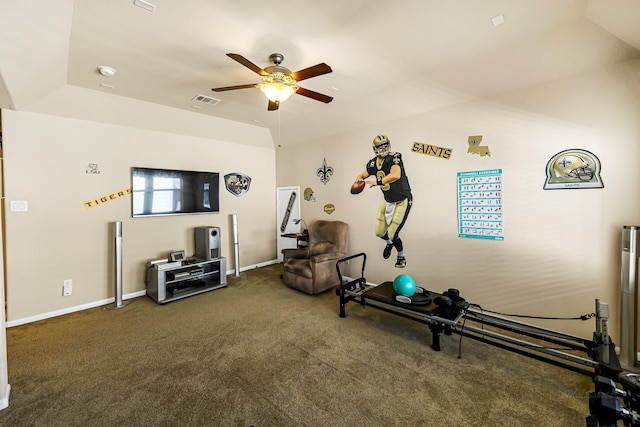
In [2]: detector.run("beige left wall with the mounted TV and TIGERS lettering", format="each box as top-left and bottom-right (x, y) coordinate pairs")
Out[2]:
(2, 102), (276, 323)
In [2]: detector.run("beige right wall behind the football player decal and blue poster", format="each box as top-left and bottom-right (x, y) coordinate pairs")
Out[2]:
(277, 62), (640, 337)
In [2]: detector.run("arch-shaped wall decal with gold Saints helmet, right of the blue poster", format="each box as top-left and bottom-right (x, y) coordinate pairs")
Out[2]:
(543, 149), (604, 190)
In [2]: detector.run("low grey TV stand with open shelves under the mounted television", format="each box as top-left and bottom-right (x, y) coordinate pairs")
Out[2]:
(145, 258), (227, 304)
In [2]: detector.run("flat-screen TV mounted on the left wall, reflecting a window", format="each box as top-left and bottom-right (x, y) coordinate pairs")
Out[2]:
(131, 167), (220, 217)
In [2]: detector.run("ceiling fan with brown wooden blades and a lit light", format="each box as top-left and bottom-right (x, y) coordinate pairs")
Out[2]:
(211, 53), (333, 111)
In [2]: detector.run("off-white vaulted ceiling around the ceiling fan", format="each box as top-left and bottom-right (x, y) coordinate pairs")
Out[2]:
(0, 0), (640, 145)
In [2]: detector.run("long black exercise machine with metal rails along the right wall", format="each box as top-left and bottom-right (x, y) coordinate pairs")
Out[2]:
(336, 253), (640, 427)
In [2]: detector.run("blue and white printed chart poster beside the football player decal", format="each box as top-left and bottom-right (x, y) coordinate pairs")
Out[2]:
(458, 169), (504, 240)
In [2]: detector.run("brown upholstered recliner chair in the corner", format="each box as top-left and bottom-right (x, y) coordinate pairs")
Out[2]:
(282, 220), (349, 295)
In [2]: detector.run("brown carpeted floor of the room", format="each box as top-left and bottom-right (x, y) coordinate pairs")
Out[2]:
(0, 264), (593, 427)
